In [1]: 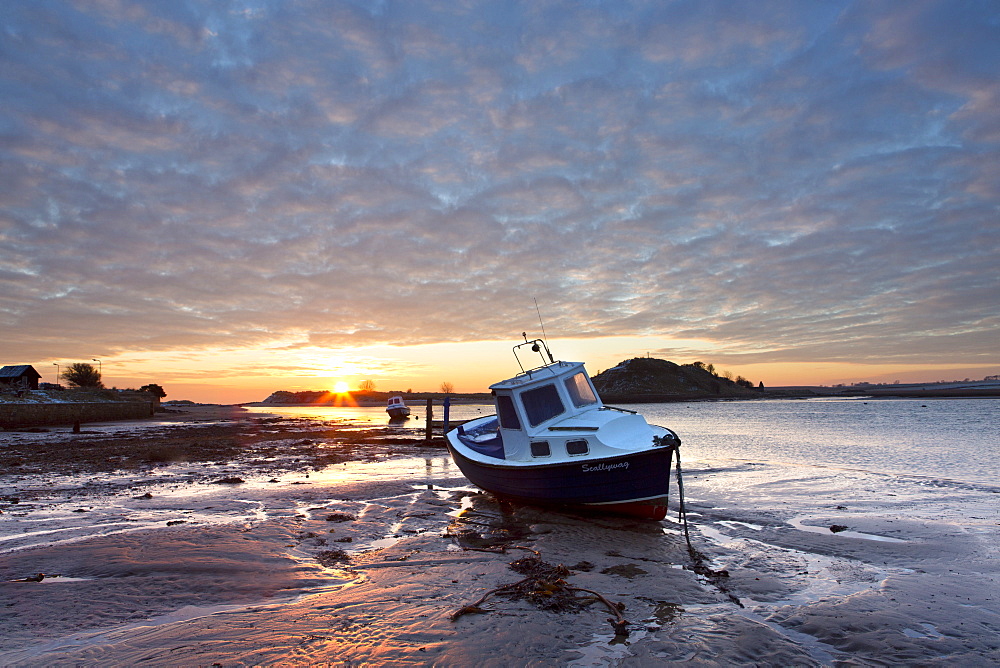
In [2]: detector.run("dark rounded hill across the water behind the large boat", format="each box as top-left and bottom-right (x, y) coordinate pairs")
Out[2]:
(592, 357), (763, 403)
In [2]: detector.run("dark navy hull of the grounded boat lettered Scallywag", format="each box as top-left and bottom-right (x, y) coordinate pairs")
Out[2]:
(448, 441), (673, 520)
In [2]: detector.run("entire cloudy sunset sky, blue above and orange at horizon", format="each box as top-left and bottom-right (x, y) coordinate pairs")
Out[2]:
(0, 0), (1000, 402)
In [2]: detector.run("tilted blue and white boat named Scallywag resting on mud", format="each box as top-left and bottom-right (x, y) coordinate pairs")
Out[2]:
(448, 336), (680, 520)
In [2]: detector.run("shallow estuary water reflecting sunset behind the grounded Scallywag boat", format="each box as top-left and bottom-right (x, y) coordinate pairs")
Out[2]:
(251, 398), (1000, 484)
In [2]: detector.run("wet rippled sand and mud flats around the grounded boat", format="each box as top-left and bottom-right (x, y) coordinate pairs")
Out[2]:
(0, 407), (1000, 666)
